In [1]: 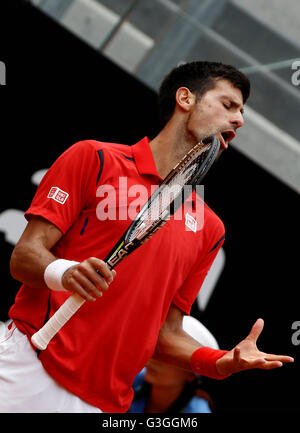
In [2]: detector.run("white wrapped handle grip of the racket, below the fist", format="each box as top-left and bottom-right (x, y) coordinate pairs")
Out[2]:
(31, 293), (85, 350)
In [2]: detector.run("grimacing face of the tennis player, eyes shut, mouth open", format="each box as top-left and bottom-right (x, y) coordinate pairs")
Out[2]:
(186, 79), (244, 152)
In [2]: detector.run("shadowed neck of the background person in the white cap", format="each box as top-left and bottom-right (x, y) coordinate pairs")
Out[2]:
(145, 384), (184, 413)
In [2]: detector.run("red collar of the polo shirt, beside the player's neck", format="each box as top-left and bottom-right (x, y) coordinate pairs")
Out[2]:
(132, 137), (162, 180)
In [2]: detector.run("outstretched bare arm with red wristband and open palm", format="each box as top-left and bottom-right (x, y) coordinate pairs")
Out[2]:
(153, 304), (294, 379)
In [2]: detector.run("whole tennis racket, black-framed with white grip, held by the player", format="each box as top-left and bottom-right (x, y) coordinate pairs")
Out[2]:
(31, 137), (220, 350)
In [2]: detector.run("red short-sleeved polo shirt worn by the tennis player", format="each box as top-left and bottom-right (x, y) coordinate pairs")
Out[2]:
(10, 138), (224, 412)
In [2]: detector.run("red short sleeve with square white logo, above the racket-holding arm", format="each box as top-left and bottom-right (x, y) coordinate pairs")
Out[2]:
(25, 141), (100, 234)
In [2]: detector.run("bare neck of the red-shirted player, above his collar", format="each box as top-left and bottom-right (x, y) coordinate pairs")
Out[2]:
(150, 117), (196, 179)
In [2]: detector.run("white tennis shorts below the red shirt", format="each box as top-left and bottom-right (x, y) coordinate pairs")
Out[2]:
(0, 321), (102, 413)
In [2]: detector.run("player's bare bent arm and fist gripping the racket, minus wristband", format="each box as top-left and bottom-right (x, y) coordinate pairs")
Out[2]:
(10, 217), (116, 301)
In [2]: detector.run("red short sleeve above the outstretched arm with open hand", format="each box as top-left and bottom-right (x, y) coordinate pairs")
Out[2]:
(172, 235), (225, 314)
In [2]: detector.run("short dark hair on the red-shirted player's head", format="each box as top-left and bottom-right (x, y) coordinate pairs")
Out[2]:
(158, 61), (250, 126)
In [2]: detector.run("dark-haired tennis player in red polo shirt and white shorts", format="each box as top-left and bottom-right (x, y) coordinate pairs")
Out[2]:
(0, 62), (293, 412)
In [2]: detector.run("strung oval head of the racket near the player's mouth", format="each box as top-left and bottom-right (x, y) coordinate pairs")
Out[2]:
(124, 137), (220, 243)
